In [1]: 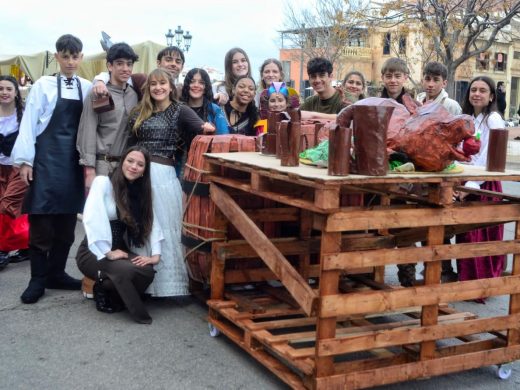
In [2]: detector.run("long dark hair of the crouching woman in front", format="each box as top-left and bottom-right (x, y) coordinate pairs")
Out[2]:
(110, 146), (153, 244)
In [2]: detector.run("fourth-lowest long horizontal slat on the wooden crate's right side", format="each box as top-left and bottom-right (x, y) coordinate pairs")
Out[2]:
(323, 239), (520, 272)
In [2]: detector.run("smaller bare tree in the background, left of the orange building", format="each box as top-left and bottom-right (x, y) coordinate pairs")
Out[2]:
(282, 0), (367, 80)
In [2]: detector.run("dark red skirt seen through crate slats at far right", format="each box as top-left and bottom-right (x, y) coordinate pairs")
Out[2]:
(457, 181), (506, 281)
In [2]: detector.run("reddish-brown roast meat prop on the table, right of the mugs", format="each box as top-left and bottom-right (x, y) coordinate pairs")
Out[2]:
(387, 104), (480, 172)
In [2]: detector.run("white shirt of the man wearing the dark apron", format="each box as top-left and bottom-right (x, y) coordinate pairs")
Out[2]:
(11, 76), (92, 166)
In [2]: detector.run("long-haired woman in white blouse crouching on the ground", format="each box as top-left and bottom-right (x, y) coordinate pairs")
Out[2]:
(76, 146), (163, 324)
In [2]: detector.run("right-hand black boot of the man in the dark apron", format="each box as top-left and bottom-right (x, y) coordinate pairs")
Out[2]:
(45, 242), (81, 290)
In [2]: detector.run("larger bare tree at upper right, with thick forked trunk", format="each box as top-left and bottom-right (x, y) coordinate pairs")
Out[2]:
(378, 0), (520, 95)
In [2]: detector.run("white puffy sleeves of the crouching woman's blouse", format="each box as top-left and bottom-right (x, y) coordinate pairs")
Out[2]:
(83, 176), (164, 260)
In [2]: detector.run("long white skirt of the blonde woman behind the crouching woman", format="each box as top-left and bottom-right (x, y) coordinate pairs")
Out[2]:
(146, 162), (188, 297)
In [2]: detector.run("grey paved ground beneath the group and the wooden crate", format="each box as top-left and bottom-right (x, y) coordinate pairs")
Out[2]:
(0, 183), (520, 390)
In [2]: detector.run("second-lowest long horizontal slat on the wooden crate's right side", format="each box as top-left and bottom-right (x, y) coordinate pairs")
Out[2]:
(317, 314), (520, 356)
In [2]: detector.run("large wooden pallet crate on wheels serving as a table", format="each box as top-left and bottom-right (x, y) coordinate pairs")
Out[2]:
(206, 153), (520, 389)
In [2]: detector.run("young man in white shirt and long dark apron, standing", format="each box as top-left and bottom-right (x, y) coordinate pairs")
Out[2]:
(12, 34), (92, 303)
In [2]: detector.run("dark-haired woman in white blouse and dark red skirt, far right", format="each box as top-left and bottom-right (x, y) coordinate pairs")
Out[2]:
(457, 76), (505, 290)
